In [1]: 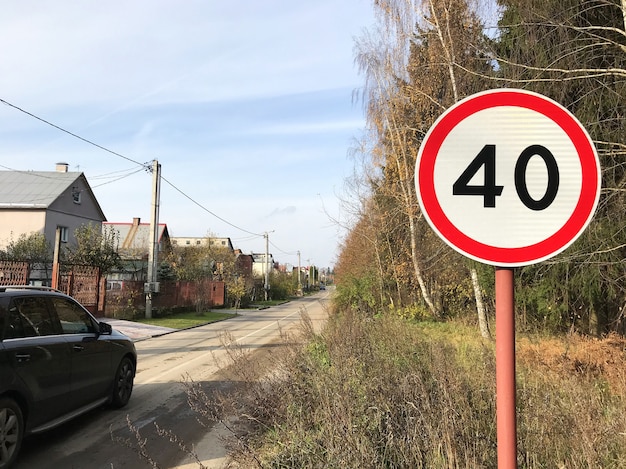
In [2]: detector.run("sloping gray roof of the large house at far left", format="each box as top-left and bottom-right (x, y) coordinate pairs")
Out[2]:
(0, 171), (83, 208)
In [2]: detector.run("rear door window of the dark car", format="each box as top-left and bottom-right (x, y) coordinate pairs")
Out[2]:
(5, 296), (60, 339)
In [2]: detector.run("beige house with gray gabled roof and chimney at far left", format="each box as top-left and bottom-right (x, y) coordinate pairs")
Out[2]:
(0, 163), (106, 249)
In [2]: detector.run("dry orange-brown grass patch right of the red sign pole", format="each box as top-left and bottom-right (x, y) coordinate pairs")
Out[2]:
(517, 330), (626, 468)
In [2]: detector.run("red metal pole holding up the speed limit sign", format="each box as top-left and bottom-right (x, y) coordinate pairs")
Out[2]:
(496, 267), (517, 469)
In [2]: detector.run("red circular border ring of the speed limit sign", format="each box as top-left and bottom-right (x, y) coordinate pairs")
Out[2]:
(416, 89), (601, 266)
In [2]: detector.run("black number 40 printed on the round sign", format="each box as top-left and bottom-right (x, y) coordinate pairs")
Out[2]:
(452, 145), (559, 210)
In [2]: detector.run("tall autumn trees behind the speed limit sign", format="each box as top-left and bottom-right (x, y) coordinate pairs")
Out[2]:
(336, 0), (626, 336)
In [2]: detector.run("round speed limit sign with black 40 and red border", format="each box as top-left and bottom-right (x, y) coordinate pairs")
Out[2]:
(415, 89), (601, 267)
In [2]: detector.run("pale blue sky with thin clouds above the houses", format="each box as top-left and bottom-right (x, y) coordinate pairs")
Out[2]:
(0, 0), (374, 268)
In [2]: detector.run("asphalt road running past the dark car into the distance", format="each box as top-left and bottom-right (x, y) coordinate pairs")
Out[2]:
(14, 292), (328, 469)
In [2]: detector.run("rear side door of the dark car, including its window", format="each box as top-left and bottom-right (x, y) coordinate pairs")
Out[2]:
(2, 295), (71, 427)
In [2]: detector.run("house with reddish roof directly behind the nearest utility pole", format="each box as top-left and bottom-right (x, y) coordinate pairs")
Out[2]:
(102, 217), (171, 282)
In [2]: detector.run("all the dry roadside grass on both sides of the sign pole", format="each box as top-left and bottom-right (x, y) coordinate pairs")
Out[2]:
(188, 308), (626, 469)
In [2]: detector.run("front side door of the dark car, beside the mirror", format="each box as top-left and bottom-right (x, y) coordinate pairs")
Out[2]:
(51, 297), (115, 407)
